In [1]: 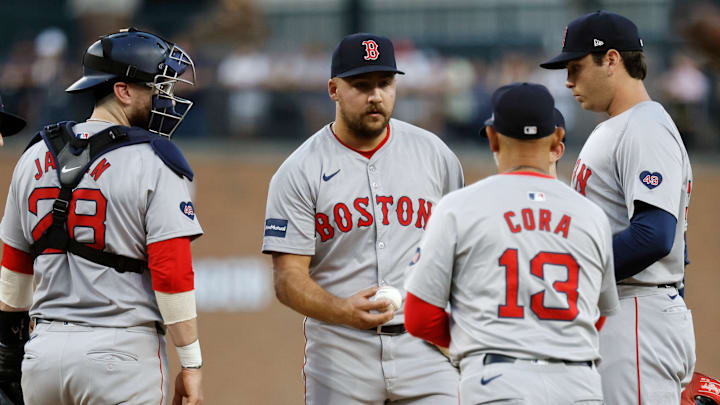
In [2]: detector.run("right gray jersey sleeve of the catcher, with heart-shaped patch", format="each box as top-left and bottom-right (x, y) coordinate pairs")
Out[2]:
(145, 159), (203, 244)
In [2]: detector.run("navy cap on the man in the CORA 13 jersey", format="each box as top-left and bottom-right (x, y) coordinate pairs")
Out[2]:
(480, 83), (565, 139)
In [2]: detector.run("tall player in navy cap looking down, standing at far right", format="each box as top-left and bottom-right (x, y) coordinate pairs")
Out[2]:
(540, 11), (695, 404)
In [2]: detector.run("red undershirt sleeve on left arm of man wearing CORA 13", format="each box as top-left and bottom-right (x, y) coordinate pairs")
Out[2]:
(405, 292), (450, 347)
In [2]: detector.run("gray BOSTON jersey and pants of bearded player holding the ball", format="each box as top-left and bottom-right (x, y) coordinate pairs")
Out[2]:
(262, 119), (463, 404)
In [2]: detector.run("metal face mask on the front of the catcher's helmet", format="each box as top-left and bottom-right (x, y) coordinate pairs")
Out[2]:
(148, 45), (195, 138)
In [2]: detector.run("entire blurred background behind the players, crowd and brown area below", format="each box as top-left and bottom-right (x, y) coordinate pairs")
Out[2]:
(0, 0), (720, 405)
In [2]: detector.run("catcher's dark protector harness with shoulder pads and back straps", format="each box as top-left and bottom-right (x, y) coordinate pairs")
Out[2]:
(25, 121), (193, 273)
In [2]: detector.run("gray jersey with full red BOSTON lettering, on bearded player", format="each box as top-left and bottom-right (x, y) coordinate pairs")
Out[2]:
(262, 119), (463, 324)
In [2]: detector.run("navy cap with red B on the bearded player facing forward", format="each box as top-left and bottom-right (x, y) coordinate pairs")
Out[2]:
(330, 32), (405, 77)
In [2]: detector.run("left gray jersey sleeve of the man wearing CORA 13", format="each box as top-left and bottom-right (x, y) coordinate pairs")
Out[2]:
(405, 200), (457, 308)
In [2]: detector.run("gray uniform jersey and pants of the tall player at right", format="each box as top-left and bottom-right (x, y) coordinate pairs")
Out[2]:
(572, 101), (695, 404)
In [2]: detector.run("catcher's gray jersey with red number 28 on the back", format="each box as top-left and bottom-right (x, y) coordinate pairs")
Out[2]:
(0, 121), (202, 327)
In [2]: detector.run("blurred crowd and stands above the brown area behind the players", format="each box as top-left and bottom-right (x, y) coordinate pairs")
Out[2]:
(0, 0), (720, 152)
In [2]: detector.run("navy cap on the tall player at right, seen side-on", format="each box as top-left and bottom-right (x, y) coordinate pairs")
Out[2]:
(540, 11), (643, 69)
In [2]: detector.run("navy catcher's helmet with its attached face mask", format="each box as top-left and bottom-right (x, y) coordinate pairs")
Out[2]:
(65, 28), (195, 137)
